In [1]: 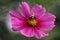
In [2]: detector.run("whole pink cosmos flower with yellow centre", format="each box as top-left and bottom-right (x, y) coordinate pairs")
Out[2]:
(9, 2), (56, 39)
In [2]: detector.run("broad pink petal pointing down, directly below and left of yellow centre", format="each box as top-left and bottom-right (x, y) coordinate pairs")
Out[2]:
(20, 26), (34, 37)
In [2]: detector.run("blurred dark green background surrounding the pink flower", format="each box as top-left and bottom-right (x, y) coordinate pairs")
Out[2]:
(0, 0), (60, 40)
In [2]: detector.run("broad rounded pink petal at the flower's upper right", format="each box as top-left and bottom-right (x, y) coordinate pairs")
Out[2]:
(32, 4), (46, 18)
